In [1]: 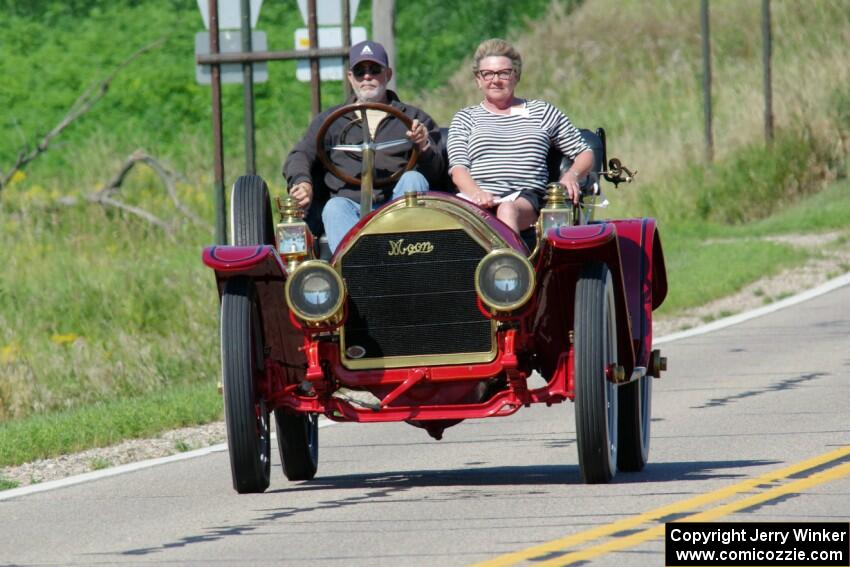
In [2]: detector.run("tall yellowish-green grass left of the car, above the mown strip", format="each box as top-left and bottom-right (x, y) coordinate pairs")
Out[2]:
(0, 191), (218, 421)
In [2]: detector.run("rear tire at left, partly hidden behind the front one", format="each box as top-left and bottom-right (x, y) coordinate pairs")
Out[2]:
(274, 409), (319, 480)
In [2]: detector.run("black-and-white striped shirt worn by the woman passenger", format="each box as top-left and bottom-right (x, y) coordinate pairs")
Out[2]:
(448, 100), (589, 199)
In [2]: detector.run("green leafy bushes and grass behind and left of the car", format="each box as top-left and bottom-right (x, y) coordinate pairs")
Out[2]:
(0, 0), (569, 474)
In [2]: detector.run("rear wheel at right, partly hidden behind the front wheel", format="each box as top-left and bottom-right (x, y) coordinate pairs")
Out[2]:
(617, 376), (652, 472)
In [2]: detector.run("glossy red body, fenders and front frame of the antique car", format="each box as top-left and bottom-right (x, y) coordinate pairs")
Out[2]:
(203, 193), (667, 430)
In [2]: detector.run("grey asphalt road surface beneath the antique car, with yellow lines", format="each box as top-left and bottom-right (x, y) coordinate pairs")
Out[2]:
(0, 286), (850, 566)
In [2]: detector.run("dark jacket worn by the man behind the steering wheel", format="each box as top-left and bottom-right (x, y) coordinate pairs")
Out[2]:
(283, 90), (446, 208)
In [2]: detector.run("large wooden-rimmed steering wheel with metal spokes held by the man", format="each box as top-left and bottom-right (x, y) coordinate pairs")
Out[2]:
(316, 102), (419, 187)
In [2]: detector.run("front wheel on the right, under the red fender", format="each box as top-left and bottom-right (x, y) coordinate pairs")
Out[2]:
(575, 262), (617, 484)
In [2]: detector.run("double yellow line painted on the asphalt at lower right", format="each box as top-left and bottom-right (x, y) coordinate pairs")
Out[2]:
(475, 445), (850, 567)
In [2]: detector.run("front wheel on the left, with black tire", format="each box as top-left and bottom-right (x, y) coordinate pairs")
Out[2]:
(221, 278), (271, 494)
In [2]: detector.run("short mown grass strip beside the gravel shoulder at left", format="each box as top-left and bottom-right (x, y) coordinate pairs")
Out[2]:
(0, 381), (222, 466)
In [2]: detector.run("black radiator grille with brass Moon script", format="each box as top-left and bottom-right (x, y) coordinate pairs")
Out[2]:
(341, 230), (492, 359)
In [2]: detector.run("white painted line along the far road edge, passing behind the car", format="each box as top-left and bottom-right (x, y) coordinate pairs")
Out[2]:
(0, 273), (850, 500)
